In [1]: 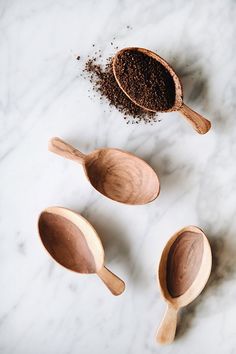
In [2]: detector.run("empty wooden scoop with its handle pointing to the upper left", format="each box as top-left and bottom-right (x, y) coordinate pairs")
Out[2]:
(49, 138), (160, 204)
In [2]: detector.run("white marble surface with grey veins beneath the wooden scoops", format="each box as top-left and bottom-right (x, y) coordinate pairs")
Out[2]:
(0, 0), (236, 354)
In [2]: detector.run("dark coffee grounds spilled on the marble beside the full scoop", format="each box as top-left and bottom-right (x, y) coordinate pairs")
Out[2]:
(83, 55), (157, 124)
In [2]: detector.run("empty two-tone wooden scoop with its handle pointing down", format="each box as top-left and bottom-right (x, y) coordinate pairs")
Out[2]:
(157, 226), (212, 344)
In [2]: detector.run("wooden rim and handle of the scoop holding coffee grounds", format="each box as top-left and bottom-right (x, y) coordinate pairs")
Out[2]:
(113, 47), (211, 134)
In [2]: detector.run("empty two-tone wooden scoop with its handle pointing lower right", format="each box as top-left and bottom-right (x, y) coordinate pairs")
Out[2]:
(38, 207), (125, 295)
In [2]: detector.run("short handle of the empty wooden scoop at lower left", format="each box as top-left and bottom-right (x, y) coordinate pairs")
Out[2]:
(97, 266), (125, 296)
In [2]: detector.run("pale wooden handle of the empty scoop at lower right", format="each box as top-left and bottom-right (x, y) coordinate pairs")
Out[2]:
(156, 305), (178, 344)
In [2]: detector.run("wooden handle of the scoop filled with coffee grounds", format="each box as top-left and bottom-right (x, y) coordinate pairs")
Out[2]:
(179, 103), (211, 134)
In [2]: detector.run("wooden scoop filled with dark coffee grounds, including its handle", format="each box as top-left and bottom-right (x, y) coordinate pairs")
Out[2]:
(113, 47), (211, 134)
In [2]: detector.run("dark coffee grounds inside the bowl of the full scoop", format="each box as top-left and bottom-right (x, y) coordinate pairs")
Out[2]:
(116, 49), (175, 112)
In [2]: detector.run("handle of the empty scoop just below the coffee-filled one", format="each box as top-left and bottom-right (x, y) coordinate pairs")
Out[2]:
(48, 138), (85, 163)
